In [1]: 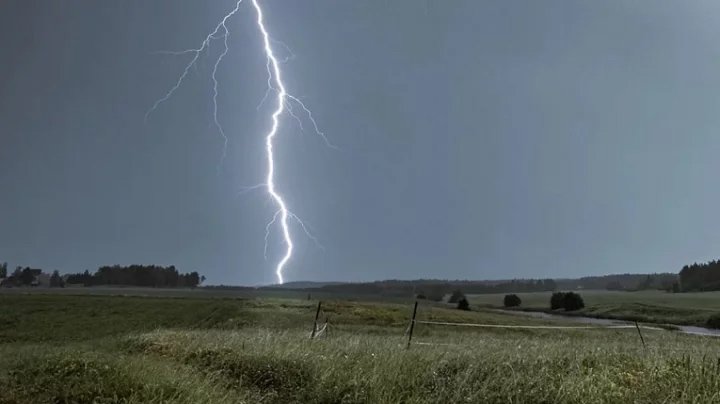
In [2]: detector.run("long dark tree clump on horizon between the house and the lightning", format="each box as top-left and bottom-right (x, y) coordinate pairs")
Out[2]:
(66, 265), (205, 288)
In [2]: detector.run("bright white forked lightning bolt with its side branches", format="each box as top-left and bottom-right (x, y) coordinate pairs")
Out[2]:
(145, 0), (335, 284)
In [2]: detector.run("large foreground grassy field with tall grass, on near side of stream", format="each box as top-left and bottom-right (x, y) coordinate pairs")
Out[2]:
(0, 294), (720, 404)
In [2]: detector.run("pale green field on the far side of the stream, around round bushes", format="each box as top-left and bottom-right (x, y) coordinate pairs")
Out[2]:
(468, 290), (720, 326)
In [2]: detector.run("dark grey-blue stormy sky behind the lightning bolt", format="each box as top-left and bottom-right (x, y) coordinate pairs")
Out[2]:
(0, 0), (720, 284)
